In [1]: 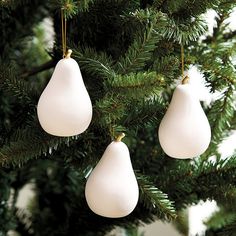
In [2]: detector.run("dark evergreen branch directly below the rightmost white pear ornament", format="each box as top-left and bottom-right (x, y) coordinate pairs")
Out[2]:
(157, 156), (236, 209)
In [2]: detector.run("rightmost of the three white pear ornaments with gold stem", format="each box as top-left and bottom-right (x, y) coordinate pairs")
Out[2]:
(158, 77), (211, 159)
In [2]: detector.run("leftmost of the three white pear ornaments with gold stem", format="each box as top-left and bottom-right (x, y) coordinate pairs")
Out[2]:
(37, 50), (92, 137)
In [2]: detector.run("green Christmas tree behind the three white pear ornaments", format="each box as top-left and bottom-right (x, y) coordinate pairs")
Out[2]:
(0, 0), (236, 236)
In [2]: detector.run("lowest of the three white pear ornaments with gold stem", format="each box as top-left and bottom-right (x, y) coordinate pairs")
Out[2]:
(85, 136), (139, 218)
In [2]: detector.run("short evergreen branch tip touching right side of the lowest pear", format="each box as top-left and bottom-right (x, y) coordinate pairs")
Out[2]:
(137, 174), (177, 220)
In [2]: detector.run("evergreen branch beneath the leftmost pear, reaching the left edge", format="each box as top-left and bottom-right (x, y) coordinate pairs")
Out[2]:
(0, 119), (81, 166)
